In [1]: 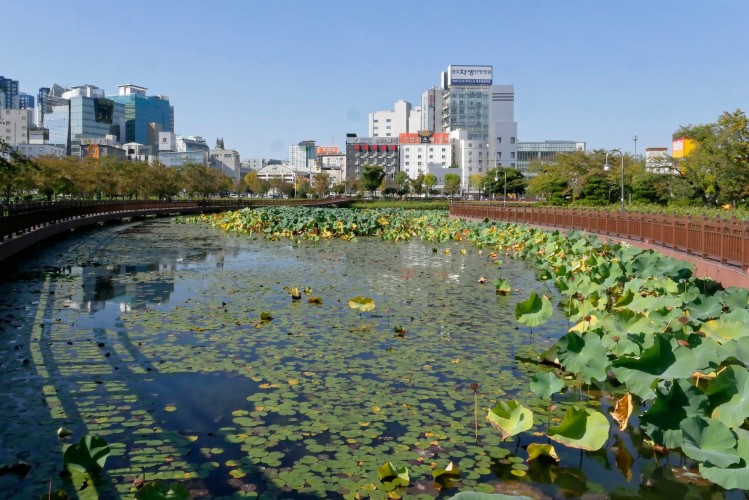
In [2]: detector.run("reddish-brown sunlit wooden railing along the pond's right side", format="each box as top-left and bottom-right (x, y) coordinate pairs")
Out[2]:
(450, 202), (749, 270)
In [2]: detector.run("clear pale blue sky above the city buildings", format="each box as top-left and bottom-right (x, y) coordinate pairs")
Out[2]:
(0, 0), (749, 159)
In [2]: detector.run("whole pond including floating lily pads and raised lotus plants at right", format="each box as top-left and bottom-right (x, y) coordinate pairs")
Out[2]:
(0, 207), (749, 498)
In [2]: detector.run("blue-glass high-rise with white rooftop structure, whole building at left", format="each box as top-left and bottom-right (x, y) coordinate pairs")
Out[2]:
(109, 84), (174, 148)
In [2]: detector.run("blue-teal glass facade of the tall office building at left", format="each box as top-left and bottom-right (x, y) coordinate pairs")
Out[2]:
(109, 94), (174, 144)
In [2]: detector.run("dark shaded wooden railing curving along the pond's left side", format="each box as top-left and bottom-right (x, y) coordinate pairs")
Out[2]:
(0, 198), (347, 261)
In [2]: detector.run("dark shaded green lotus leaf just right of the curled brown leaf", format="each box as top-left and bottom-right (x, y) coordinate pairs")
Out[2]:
(640, 379), (709, 448)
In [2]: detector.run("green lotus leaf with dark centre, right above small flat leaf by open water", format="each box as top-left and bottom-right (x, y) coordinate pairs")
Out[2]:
(557, 332), (609, 384)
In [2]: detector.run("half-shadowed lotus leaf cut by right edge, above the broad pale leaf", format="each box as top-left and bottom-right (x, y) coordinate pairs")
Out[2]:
(705, 365), (749, 428)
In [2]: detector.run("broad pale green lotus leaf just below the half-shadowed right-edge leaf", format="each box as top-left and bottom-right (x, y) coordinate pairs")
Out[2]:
(681, 416), (740, 467)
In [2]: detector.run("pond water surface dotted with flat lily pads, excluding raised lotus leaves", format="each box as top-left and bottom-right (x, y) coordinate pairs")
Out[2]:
(0, 219), (736, 498)
